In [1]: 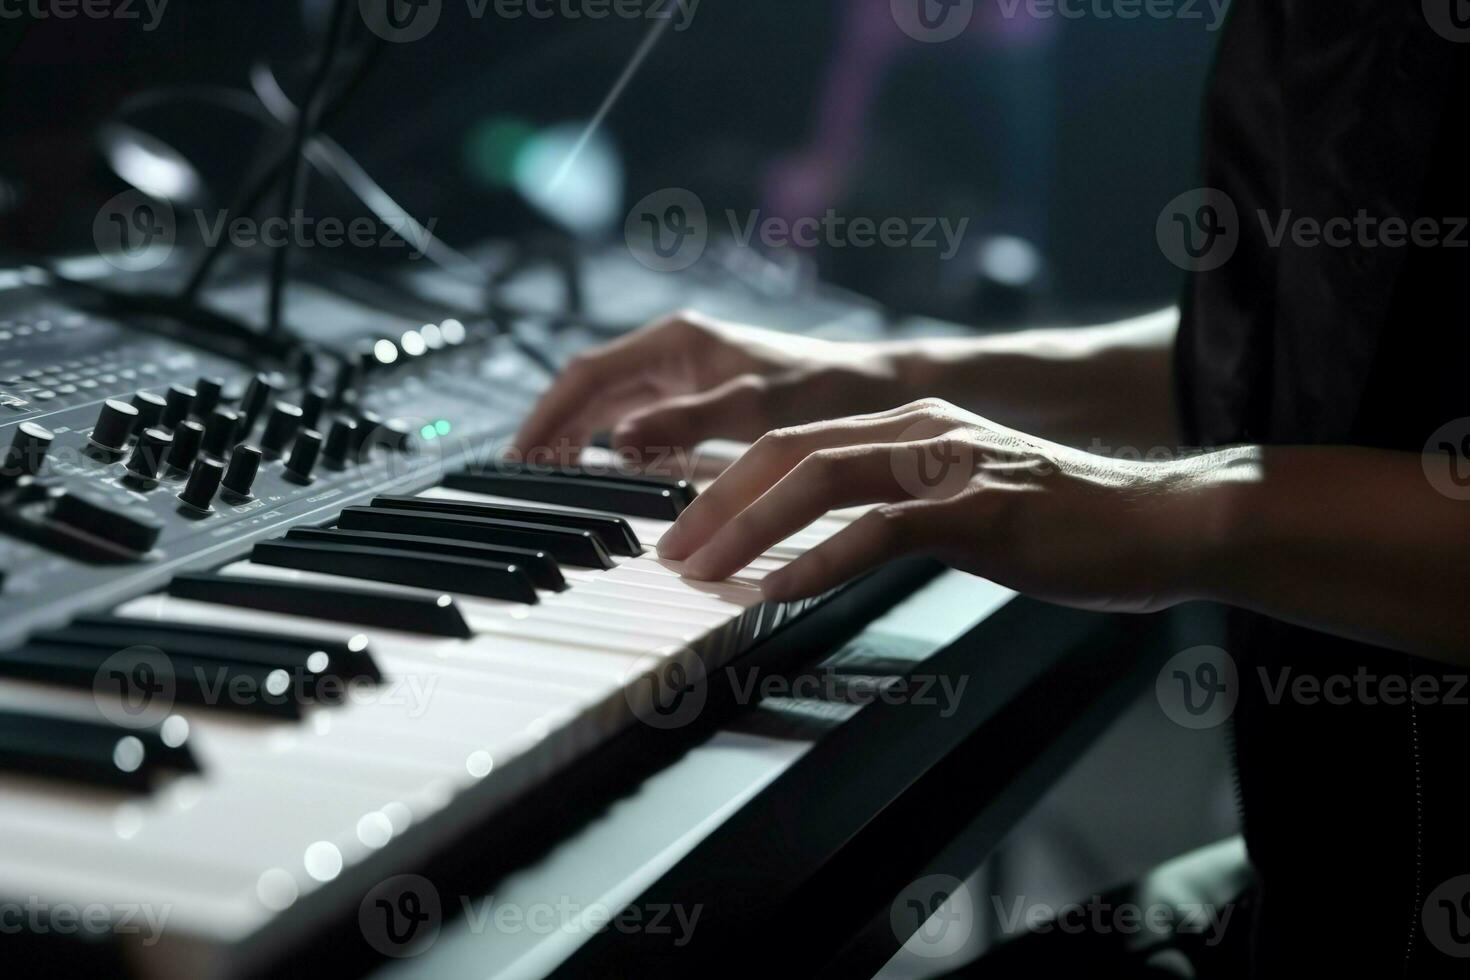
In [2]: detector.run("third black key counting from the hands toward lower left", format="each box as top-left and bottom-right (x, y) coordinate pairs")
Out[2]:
(337, 507), (614, 569)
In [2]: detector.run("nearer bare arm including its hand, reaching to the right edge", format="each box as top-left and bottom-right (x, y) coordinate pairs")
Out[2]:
(659, 401), (1470, 666)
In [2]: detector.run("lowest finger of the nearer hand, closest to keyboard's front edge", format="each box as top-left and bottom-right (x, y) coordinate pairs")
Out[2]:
(760, 500), (954, 602)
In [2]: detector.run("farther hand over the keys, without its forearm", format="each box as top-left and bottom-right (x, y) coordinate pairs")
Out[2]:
(513, 311), (904, 461)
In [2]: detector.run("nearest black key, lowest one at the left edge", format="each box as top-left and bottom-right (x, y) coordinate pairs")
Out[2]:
(0, 711), (198, 792)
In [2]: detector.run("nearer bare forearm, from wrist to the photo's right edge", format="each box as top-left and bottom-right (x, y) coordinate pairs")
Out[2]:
(1186, 447), (1470, 666)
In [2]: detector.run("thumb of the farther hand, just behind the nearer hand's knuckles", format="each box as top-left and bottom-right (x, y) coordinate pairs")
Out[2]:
(613, 375), (770, 451)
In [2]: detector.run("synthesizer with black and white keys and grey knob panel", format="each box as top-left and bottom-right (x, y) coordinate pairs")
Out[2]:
(0, 270), (917, 977)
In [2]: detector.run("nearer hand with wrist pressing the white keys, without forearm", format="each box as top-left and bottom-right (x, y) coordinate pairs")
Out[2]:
(659, 400), (1232, 611)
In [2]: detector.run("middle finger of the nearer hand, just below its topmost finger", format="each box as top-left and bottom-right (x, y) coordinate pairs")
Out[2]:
(685, 444), (913, 580)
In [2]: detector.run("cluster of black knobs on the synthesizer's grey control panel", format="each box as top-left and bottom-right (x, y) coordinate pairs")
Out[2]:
(76, 372), (381, 511)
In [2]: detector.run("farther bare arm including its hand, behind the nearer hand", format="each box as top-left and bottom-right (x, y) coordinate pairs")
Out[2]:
(515, 310), (1179, 455)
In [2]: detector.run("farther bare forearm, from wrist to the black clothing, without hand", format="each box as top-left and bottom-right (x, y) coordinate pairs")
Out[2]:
(892, 309), (1179, 457)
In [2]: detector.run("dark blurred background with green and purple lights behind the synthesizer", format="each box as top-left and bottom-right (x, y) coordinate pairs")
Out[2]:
(0, 0), (1219, 329)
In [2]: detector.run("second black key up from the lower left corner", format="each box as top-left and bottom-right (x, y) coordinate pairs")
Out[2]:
(0, 642), (310, 718)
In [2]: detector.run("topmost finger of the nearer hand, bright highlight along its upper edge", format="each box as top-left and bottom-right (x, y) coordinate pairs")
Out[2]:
(659, 413), (939, 561)
